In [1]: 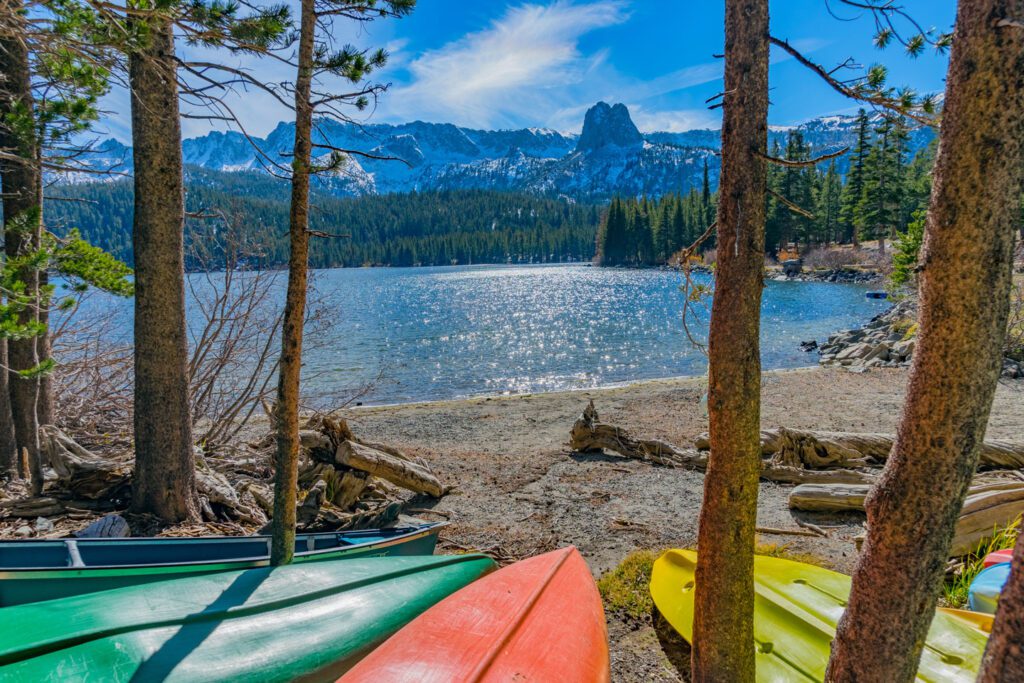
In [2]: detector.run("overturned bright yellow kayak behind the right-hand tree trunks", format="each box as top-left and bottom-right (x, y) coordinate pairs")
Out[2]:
(650, 550), (990, 682)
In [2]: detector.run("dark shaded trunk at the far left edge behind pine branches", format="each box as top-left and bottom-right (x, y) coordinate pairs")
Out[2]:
(0, 6), (43, 496)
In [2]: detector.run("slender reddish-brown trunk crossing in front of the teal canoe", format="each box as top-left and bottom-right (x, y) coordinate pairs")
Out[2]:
(270, 0), (316, 565)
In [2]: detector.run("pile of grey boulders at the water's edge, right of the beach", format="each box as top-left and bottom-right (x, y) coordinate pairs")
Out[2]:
(801, 297), (1024, 379)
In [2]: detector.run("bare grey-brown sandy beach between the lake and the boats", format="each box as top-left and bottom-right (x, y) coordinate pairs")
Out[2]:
(345, 368), (1024, 681)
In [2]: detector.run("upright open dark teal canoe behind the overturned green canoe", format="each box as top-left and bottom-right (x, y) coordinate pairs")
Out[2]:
(0, 522), (446, 607)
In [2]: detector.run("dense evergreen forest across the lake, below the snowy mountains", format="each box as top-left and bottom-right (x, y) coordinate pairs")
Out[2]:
(46, 174), (602, 270)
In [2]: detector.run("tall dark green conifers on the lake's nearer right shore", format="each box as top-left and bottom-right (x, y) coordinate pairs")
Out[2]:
(597, 112), (935, 265)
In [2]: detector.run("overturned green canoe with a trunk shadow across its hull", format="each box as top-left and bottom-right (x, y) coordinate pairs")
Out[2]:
(0, 555), (495, 683)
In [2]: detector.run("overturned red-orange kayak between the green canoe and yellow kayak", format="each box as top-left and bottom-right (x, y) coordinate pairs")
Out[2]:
(339, 547), (610, 683)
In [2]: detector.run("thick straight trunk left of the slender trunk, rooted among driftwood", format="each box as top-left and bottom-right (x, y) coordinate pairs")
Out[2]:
(128, 19), (199, 523)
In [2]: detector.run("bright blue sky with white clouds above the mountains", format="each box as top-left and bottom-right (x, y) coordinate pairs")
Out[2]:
(99, 0), (955, 139)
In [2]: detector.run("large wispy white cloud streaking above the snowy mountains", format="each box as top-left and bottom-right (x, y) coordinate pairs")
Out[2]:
(387, 0), (628, 127)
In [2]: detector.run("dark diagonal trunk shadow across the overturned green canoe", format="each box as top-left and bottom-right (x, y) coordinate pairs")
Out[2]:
(131, 567), (272, 683)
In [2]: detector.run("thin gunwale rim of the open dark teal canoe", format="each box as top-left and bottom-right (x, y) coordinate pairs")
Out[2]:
(0, 521), (449, 581)
